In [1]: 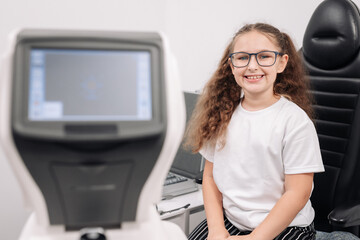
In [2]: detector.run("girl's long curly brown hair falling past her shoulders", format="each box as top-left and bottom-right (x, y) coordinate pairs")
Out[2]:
(185, 23), (313, 152)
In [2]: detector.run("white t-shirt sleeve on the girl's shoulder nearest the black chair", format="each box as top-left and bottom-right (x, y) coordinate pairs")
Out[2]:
(283, 116), (324, 174)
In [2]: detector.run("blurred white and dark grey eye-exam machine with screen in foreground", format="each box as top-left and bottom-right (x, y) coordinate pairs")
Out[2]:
(0, 29), (186, 240)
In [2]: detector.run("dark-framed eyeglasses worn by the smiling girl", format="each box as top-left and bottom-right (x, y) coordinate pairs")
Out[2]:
(229, 51), (284, 68)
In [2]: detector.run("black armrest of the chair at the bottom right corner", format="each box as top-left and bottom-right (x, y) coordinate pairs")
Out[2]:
(328, 201), (360, 228)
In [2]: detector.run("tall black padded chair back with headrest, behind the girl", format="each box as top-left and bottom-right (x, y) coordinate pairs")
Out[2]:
(300, 0), (360, 234)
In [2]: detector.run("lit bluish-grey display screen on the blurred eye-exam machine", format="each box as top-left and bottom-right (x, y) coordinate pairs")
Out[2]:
(28, 48), (152, 122)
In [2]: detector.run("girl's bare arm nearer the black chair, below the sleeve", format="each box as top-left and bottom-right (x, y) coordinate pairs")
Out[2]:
(229, 173), (314, 240)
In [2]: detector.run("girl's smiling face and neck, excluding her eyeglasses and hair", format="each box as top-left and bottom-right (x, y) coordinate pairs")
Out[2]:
(229, 31), (288, 99)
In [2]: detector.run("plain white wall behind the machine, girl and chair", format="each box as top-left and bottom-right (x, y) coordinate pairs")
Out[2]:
(0, 0), (360, 240)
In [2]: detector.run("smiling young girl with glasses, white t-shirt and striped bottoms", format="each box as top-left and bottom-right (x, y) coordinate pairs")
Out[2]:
(187, 23), (324, 240)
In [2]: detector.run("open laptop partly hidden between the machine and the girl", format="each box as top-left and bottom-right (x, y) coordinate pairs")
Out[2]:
(162, 92), (204, 199)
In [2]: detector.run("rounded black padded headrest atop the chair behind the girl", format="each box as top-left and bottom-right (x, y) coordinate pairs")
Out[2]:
(303, 0), (360, 70)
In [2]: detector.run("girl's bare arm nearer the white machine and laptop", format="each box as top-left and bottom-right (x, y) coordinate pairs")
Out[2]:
(202, 161), (230, 240)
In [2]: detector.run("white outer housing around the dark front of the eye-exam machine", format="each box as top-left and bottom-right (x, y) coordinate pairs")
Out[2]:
(0, 29), (186, 240)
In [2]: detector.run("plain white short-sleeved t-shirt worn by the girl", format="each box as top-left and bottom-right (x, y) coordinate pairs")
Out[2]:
(200, 97), (324, 231)
